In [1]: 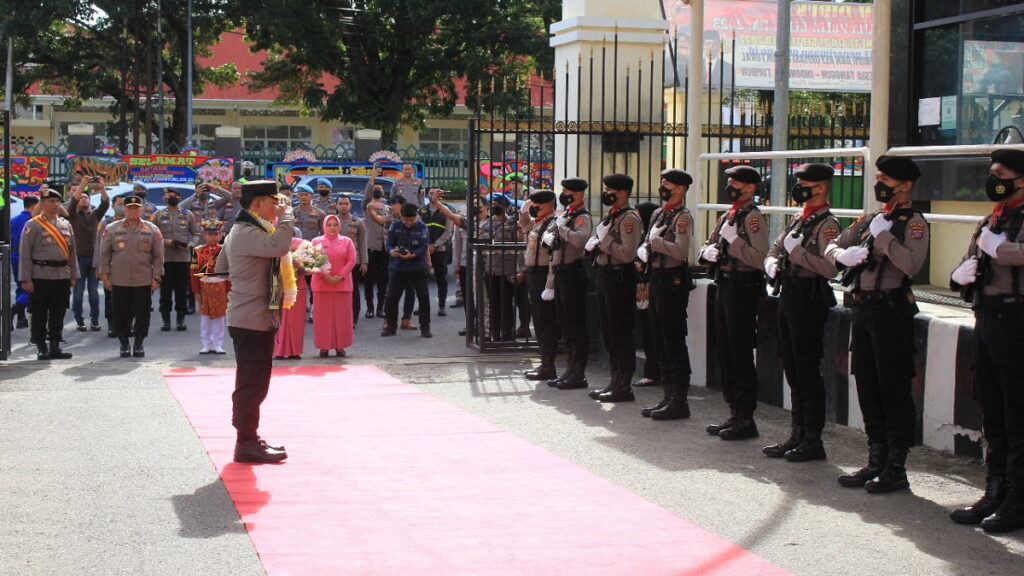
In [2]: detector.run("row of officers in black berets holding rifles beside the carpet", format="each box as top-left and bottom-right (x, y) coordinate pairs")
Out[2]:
(499, 150), (1024, 532)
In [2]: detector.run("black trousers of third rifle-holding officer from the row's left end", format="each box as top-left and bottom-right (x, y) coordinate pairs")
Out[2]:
(597, 264), (637, 378)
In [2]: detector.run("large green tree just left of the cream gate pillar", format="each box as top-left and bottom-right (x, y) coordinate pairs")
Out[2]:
(239, 0), (561, 145)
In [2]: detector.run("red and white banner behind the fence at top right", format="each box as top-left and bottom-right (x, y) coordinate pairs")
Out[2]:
(663, 0), (874, 92)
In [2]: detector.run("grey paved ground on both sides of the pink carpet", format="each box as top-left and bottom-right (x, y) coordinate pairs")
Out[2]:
(0, 286), (1024, 576)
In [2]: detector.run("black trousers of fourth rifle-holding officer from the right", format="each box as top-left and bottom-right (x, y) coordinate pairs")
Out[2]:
(715, 272), (765, 418)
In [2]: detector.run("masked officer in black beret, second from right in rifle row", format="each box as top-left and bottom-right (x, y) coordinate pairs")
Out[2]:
(825, 156), (928, 493)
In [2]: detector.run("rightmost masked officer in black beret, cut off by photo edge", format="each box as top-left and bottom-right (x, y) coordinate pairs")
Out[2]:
(949, 150), (1024, 533)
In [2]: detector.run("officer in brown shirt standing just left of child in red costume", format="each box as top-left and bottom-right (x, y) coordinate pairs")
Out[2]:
(153, 188), (200, 332)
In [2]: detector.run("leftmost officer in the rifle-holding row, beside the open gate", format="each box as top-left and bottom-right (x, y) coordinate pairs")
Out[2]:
(524, 190), (558, 380)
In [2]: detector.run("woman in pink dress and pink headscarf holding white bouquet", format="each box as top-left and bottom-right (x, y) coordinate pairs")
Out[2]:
(310, 214), (355, 358)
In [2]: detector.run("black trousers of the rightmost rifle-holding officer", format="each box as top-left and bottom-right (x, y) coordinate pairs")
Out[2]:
(974, 304), (1024, 481)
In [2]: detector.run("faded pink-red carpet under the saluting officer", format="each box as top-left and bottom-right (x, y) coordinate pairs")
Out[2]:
(165, 366), (787, 576)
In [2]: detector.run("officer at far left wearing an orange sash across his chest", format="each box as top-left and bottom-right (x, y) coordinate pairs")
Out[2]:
(18, 188), (79, 360)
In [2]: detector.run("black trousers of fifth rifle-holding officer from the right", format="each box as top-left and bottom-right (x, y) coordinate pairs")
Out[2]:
(649, 266), (690, 401)
